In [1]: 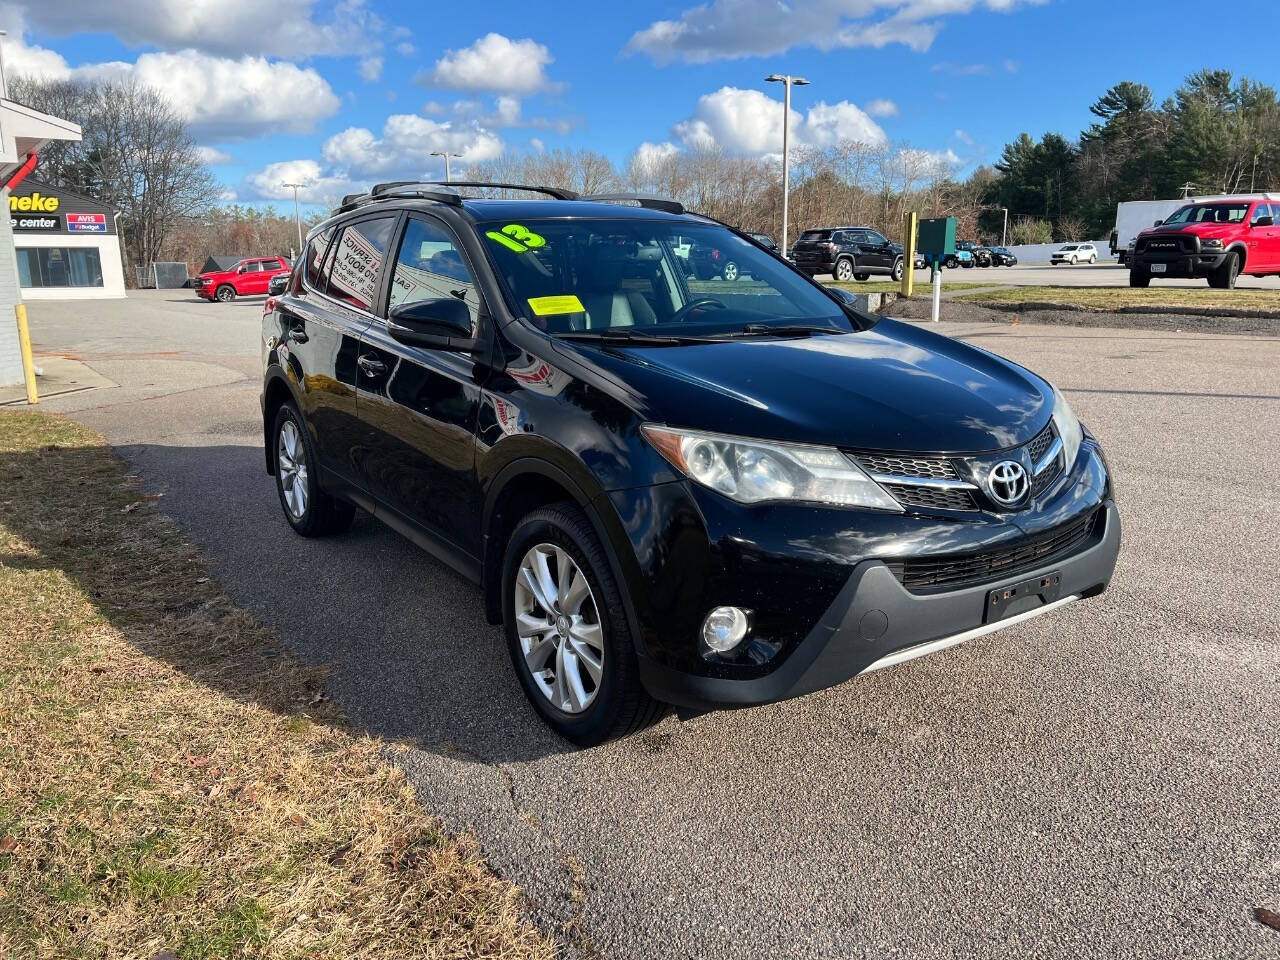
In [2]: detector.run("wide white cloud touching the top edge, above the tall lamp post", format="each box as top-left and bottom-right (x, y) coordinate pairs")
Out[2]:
(626, 0), (1047, 64)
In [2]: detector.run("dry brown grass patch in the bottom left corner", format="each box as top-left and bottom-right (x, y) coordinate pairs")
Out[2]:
(0, 413), (556, 960)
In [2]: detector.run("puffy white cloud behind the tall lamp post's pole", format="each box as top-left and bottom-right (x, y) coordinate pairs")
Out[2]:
(671, 87), (884, 155)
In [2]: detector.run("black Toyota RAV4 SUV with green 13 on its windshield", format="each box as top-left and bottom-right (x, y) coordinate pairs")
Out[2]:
(262, 183), (1120, 745)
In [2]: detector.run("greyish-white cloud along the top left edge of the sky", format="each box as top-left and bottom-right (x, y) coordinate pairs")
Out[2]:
(6, 0), (385, 56)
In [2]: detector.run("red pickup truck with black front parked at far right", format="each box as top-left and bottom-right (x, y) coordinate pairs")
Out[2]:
(1129, 196), (1280, 289)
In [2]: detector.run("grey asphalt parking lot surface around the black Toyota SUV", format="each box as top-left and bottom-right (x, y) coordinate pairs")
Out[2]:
(22, 289), (1280, 960)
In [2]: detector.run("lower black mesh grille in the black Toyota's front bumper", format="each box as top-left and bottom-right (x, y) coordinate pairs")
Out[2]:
(886, 508), (1102, 591)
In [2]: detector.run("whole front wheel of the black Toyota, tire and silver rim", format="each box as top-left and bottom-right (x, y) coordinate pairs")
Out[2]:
(502, 503), (666, 746)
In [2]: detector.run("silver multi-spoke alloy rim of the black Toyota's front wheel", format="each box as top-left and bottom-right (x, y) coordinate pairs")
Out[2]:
(515, 543), (604, 713)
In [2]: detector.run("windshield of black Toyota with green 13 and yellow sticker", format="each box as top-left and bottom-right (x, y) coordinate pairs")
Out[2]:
(479, 218), (851, 339)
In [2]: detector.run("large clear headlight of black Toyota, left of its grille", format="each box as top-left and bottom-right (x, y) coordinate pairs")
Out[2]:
(643, 424), (902, 513)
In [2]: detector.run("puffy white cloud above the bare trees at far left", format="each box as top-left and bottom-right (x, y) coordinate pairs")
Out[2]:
(3, 33), (339, 138)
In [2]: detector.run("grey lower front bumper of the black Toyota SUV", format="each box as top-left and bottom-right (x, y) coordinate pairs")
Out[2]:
(640, 499), (1120, 709)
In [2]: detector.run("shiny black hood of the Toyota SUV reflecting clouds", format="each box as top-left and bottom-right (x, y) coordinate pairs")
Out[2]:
(559, 319), (1053, 453)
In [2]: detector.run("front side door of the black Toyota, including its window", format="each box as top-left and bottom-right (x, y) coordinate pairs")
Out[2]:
(357, 214), (484, 557)
